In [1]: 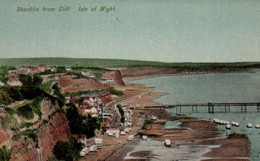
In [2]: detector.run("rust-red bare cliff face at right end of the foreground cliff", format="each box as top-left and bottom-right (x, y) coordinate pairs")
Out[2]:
(38, 113), (70, 161)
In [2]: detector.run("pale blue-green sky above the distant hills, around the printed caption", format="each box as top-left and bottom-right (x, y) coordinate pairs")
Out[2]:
(0, 0), (260, 62)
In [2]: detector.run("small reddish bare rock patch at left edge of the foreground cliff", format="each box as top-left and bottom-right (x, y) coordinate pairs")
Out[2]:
(0, 114), (13, 147)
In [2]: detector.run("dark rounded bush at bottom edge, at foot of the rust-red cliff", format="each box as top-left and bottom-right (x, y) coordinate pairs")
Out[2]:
(52, 138), (83, 161)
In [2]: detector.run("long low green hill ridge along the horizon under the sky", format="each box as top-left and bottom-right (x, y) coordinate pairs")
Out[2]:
(0, 58), (260, 68)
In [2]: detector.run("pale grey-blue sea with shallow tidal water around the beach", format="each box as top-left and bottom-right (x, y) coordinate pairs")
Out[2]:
(129, 70), (260, 161)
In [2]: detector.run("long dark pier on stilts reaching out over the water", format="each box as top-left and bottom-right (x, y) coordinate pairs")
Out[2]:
(144, 102), (260, 114)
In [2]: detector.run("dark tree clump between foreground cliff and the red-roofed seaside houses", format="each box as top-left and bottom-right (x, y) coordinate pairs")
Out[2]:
(66, 104), (100, 138)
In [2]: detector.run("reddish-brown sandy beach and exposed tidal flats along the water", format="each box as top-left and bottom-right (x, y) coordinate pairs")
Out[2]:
(80, 74), (250, 161)
